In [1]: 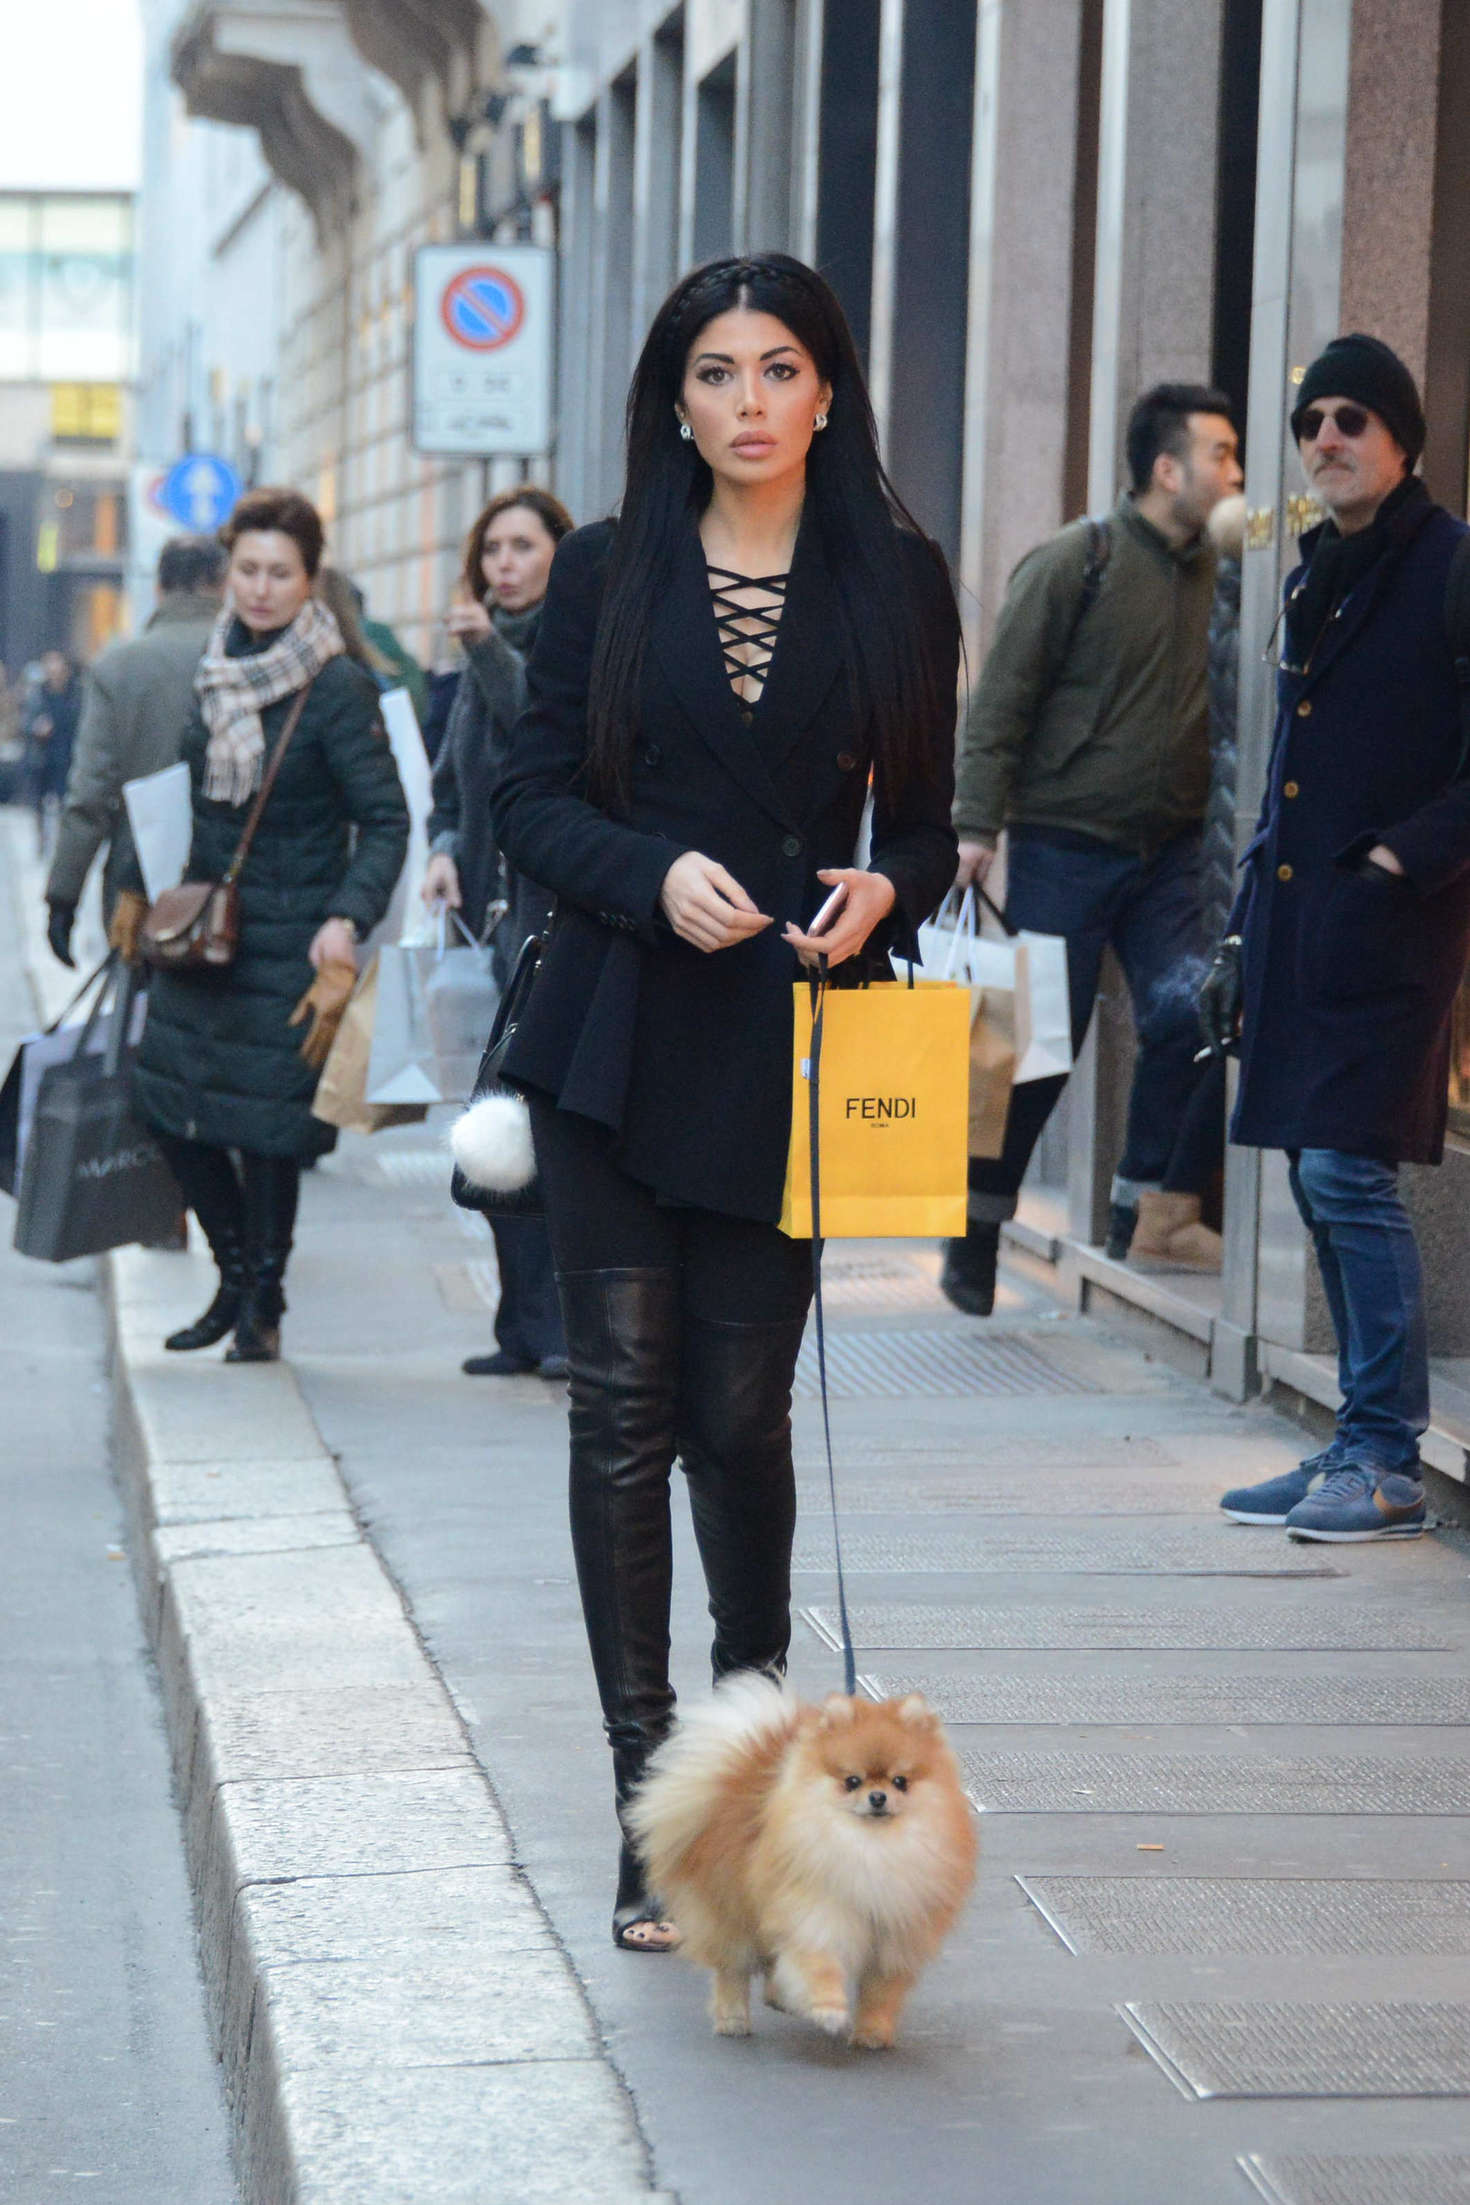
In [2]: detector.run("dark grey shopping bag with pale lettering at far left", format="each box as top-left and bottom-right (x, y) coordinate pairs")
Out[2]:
(15, 966), (183, 1263)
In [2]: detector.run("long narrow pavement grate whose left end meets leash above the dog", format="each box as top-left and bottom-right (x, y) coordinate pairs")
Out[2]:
(800, 1599), (1450, 1654)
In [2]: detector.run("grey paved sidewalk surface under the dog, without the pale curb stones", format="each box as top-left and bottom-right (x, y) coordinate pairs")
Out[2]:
(289, 1136), (1470, 2205)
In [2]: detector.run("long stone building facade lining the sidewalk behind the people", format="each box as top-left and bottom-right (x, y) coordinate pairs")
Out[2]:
(141, 0), (1470, 1472)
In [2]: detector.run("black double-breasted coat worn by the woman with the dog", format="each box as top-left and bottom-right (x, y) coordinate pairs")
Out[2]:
(491, 518), (959, 1224)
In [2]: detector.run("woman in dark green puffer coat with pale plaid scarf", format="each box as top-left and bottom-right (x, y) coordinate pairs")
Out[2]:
(121, 490), (408, 1363)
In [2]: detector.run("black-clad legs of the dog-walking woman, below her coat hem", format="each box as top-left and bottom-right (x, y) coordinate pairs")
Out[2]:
(531, 1098), (811, 1861)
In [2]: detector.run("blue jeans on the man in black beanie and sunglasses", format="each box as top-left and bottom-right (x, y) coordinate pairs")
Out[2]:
(1291, 1149), (1428, 1477)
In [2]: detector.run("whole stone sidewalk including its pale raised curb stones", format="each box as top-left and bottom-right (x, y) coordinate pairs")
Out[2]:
(11, 815), (1470, 2205)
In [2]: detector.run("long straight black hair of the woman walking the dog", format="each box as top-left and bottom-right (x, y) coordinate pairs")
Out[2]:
(588, 254), (952, 807)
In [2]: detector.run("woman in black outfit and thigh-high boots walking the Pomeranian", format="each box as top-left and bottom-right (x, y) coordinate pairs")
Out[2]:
(491, 254), (959, 1951)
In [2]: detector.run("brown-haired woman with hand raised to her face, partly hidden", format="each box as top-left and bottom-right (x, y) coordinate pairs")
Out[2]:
(423, 483), (571, 1378)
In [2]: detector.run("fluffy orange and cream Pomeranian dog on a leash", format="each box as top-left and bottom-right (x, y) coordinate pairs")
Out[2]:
(630, 1671), (979, 2048)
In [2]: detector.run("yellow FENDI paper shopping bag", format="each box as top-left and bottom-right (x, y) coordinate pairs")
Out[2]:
(780, 979), (970, 1239)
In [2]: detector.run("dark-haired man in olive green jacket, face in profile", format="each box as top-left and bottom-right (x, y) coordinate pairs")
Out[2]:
(941, 384), (1243, 1316)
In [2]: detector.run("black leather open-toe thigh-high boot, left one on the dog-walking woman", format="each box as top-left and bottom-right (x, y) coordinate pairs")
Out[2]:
(558, 1270), (679, 1951)
